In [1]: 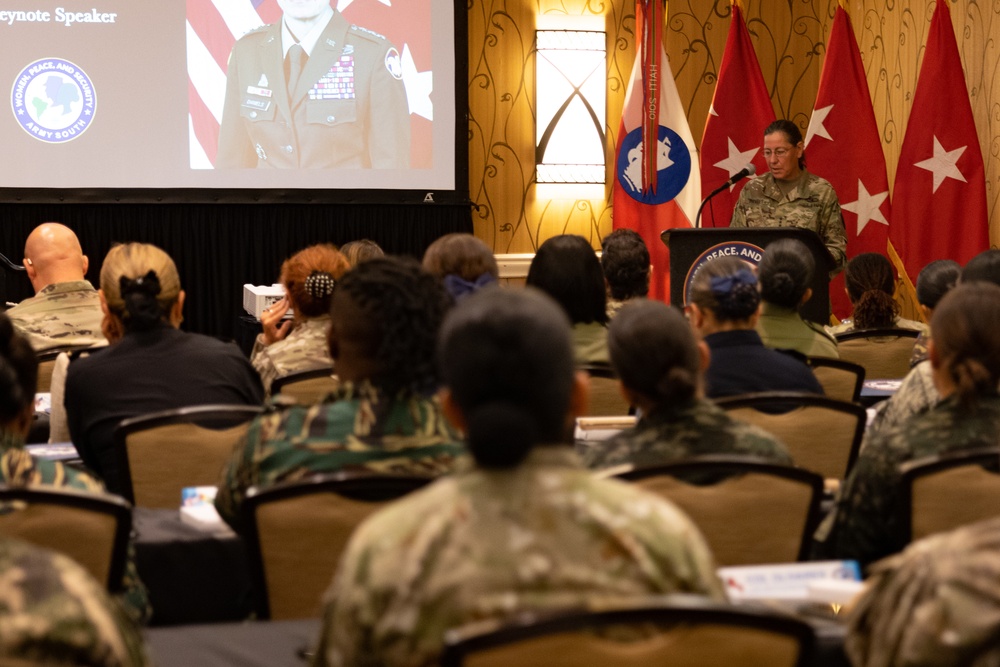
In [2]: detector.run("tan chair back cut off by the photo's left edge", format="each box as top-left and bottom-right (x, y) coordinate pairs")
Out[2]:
(0, 486), (132, 592)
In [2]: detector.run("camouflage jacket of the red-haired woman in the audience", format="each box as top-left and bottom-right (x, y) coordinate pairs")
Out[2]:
(250, 315), (333, 394)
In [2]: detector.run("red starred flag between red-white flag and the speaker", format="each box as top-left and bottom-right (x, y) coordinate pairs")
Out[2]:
(701, 0), (774, 227)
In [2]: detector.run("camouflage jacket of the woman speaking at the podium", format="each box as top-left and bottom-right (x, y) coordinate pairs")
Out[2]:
(729, 170), (847, 273)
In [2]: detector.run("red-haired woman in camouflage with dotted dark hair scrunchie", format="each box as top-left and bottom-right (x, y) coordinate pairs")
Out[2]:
(250, 245), (350, 393)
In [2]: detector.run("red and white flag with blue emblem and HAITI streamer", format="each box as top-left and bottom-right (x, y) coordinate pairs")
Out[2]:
(612, 0), (701, 301)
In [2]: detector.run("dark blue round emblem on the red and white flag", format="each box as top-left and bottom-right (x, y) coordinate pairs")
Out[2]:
(616, 125), (691, 204)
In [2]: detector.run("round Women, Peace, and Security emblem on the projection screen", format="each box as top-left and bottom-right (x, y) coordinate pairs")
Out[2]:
(10, 58), (97, 144)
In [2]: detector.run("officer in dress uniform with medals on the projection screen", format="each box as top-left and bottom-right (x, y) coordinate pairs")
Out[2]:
(215, 0), (410, 169)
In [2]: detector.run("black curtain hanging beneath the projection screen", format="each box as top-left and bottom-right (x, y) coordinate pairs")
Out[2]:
(0, 203), (472, 338)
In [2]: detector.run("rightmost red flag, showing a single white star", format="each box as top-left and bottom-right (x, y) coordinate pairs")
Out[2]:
(889, 0), (989, 280)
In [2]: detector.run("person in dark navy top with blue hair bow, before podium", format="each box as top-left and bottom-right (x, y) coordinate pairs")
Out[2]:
(689, 257), (823, 398)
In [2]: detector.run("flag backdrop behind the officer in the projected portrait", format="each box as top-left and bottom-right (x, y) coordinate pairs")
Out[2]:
(187, 0), (434, 169)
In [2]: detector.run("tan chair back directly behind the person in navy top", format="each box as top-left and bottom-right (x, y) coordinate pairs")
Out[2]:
(715, 392), (868, 479)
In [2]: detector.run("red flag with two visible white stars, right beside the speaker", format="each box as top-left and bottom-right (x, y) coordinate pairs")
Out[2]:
(806, 7), (890, 319)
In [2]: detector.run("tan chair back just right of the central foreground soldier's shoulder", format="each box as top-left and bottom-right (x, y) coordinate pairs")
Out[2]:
(618, 456), (823, 566)
